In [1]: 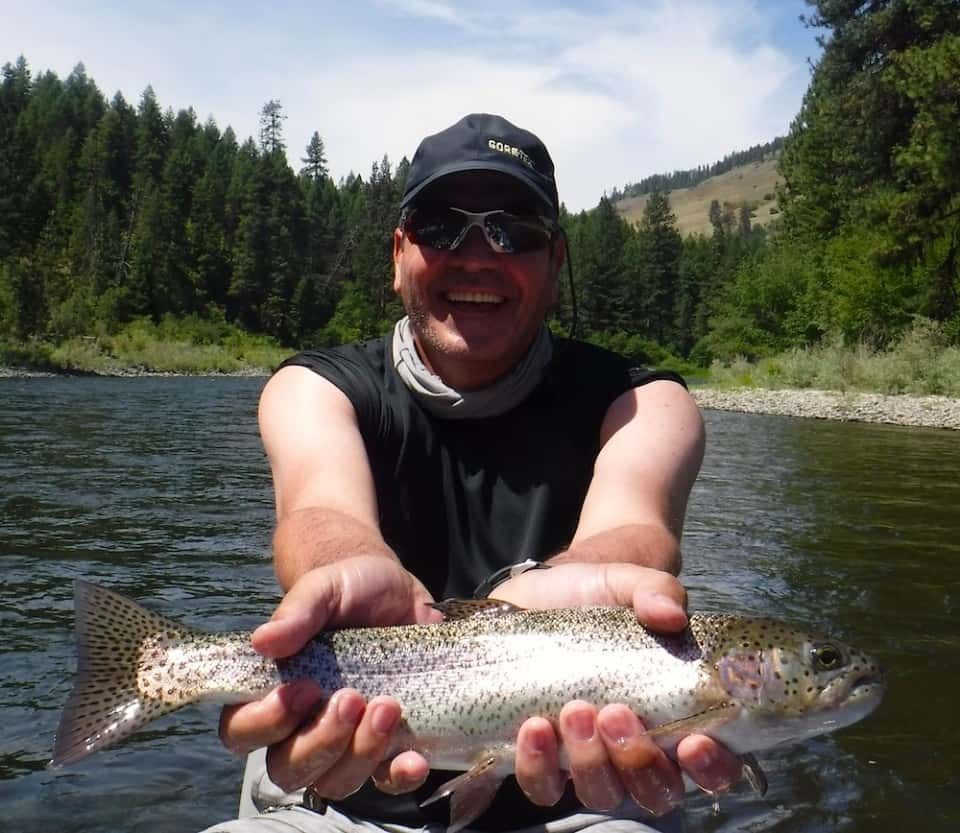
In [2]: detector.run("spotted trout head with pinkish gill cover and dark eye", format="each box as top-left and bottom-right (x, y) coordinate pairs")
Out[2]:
(692, 617), (885, 748)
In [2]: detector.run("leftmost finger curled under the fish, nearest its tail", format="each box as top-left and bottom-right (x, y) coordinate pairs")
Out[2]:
(220, 680), (324, 755)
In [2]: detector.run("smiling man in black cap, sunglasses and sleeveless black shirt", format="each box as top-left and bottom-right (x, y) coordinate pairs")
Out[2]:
(206, 114), (739, 832)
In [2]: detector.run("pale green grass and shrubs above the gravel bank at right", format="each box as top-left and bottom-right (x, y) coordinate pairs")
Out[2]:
(709, 321), (960, 397)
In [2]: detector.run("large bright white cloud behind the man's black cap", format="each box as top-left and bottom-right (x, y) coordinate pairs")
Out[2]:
(289, 2), (799, 209)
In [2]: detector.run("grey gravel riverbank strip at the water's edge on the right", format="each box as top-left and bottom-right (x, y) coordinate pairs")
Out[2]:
(691, 387), (960, 430)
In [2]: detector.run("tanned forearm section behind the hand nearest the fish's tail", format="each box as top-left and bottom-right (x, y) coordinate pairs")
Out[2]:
(273, 507), (398, 590)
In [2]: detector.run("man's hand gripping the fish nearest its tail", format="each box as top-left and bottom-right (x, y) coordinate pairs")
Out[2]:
(220, 556), (442, 799)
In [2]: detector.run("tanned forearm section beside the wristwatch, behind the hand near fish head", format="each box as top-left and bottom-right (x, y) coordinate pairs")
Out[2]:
(548, 524), (681, 575)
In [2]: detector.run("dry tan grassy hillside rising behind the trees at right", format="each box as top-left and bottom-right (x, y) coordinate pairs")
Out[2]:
(617, 159), (781, 235)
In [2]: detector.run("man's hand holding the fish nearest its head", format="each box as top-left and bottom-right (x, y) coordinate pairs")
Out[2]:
(492, 562), (740, 815)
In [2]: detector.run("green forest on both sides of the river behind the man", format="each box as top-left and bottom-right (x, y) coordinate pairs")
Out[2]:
(0, 0), (960, 365)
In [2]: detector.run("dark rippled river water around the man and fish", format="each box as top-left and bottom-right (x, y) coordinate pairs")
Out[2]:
(0, 378), (960, 833)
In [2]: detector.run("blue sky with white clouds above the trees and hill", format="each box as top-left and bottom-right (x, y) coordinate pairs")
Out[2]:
(0, 0), (819, 210)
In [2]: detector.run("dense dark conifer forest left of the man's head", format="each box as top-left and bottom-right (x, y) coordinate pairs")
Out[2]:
(0, 58), (405, 345)
